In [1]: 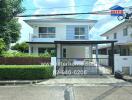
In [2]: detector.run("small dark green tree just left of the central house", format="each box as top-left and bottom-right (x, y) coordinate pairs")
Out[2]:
(11, 42), (29, 53)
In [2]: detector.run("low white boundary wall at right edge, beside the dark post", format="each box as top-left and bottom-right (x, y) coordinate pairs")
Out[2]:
(114, 55), (132, 75)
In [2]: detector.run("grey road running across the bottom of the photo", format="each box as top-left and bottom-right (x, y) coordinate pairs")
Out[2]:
(0, 84), (132, 100)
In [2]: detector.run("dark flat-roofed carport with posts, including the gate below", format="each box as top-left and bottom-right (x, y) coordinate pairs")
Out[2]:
(54, 40), (117, 75)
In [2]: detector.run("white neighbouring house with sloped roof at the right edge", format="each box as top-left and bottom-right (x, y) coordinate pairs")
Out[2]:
(99, 20), (132, 74)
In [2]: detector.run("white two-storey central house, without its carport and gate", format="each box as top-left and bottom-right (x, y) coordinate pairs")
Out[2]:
(24, 18), (97, 58)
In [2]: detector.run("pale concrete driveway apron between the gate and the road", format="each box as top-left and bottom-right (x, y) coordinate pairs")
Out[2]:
(37, 75), (132, 86)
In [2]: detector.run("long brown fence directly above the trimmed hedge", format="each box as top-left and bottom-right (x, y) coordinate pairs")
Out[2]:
(0, 57), (51, 65)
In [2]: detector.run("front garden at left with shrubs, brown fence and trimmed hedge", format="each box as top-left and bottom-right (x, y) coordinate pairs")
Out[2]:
(0, 40), (53, 80)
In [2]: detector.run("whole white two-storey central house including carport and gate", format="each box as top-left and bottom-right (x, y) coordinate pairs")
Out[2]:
(25, 18), (116, 75)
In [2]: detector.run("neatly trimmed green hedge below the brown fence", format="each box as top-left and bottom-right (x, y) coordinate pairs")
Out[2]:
(0, 65), (53, 80)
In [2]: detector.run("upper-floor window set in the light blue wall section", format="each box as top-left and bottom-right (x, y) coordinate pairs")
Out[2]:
(75, 27), (85, 39)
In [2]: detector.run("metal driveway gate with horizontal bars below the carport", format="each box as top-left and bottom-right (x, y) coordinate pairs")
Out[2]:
(56, 58), (111, 75)
